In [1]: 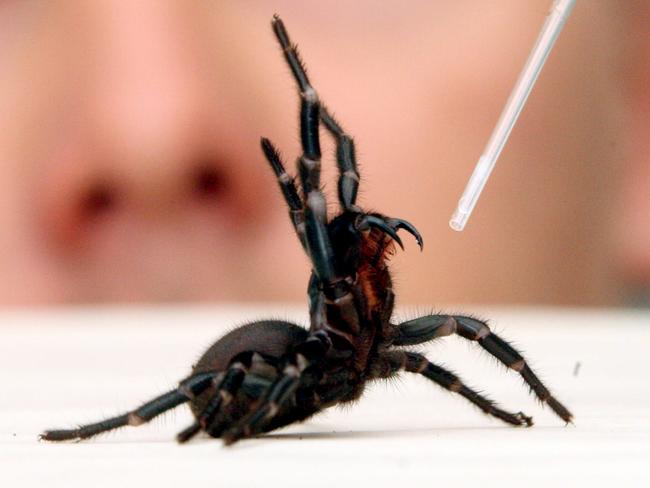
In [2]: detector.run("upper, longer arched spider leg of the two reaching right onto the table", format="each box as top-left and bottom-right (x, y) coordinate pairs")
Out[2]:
(393, 315), (573, 423)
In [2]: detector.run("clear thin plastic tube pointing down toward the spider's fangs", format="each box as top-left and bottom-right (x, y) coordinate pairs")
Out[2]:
(449, 0), (575, 231)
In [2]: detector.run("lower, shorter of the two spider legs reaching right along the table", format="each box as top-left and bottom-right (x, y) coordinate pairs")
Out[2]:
(373, 351), (533, 427)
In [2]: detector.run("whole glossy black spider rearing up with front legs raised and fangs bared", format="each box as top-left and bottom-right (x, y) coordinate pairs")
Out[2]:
(42, 16), (571, 444)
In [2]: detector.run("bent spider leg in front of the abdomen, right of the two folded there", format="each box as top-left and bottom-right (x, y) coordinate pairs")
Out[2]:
(222, 331), (332, 445)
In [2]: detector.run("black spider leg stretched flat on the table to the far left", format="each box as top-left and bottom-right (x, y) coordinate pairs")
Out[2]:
(40, 373), (213, 441)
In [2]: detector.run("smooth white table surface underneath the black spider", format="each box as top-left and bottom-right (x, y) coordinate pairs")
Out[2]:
(0, 305), (650, 488)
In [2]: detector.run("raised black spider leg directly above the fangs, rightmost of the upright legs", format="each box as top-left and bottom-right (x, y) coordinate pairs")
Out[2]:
(320, 105), (359, 211)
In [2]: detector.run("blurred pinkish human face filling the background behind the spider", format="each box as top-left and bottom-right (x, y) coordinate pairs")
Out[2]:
(0, 0), (650, 305)
